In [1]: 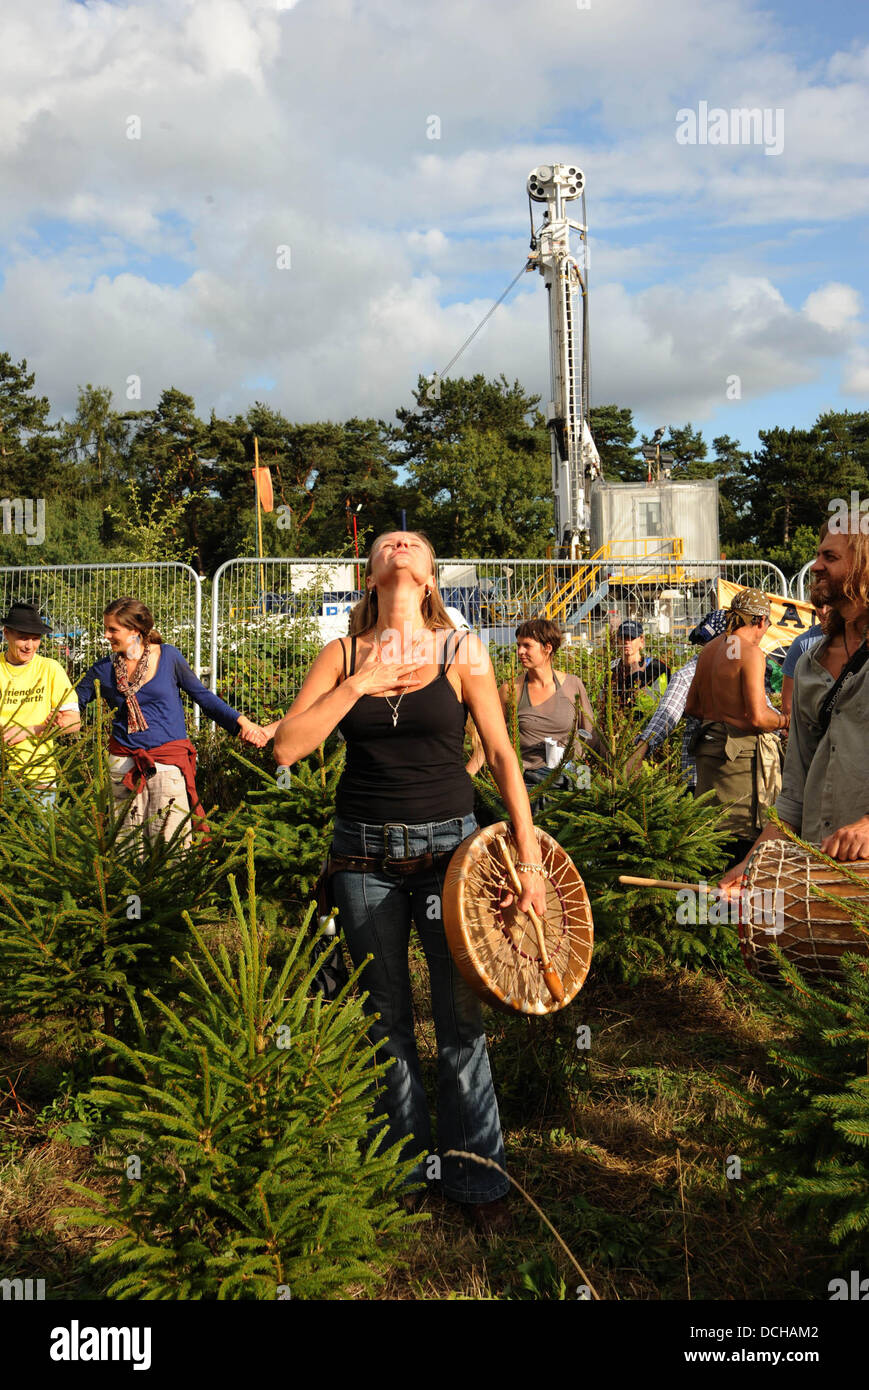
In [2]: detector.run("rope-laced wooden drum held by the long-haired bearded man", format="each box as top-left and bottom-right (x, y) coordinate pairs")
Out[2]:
(740, 840), (869, 983)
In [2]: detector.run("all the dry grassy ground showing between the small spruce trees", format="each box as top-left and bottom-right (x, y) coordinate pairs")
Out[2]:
(0, 948), (836, 1300)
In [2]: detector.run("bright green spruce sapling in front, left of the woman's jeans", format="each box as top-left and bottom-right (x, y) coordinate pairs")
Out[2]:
(63, 834), (413, 1300)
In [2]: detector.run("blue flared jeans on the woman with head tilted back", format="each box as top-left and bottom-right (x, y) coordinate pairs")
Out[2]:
(331, 816), (509, 1202)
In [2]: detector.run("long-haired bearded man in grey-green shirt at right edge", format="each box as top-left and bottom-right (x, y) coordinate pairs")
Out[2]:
(722, 523), (869, 890)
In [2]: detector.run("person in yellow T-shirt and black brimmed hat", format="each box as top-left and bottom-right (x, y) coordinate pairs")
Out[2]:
(0, 603), (81, 805)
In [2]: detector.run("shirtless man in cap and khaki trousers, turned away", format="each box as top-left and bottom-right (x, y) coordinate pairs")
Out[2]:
(685, 589), (788, 862)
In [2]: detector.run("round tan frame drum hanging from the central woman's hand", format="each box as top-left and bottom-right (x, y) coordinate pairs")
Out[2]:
(444, 820), (594, 1013)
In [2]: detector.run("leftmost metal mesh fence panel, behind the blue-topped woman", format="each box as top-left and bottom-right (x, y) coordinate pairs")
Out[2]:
(0, 560), (202, 726)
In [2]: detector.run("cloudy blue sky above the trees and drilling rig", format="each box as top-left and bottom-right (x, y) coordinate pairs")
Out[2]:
(0, 0), (869, 467)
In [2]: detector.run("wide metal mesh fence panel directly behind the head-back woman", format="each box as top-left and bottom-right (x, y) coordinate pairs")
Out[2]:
(210, 556), (788, 720)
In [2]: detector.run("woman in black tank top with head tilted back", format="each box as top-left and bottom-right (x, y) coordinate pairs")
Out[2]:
(274, 531), (545, 1232)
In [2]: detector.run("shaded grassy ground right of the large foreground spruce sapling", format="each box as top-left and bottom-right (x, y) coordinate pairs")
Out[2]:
(387, 958), (834, 1300)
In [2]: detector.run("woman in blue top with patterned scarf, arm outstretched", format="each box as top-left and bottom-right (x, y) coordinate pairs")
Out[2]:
(78, 598), (268, 848)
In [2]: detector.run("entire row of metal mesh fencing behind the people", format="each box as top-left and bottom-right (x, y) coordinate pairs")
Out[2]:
(0, 555), (808, 726)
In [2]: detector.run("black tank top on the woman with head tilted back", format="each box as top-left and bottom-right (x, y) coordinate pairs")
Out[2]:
(335, 631), (474, 826)
